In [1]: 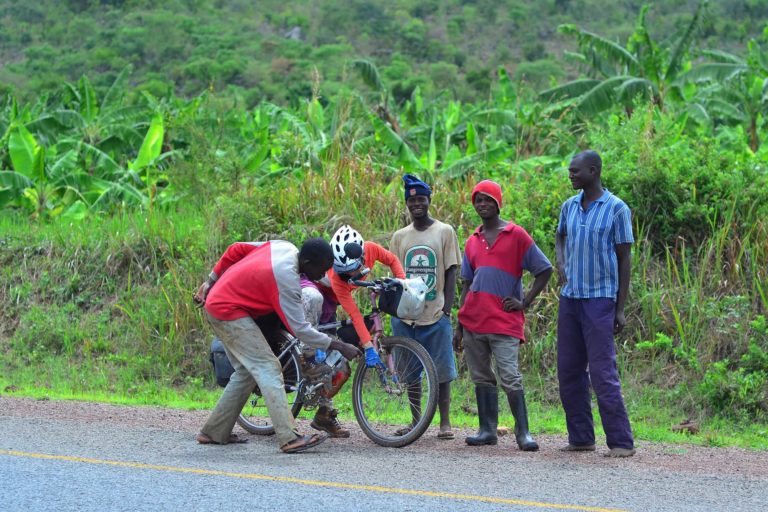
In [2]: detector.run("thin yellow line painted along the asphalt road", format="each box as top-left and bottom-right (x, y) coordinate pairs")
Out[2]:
(0, 450), (625, 512)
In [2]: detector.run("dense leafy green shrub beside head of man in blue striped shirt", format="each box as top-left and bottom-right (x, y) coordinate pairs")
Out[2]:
(593, 107), (768, 249)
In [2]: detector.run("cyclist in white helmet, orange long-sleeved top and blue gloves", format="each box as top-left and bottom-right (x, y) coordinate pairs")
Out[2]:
(302, 225), (405, 437)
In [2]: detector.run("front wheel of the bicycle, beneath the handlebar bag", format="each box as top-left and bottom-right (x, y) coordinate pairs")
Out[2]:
(352, 336), (438, 447)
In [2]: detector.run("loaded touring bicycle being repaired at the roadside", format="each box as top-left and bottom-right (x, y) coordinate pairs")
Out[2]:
(237, 280), (438, 447)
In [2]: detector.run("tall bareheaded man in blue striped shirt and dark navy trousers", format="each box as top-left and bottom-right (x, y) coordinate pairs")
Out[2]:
(555, 151), (635, 457)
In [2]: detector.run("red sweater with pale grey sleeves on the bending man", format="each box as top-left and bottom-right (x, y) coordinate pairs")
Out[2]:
(205, 240), (331, 349)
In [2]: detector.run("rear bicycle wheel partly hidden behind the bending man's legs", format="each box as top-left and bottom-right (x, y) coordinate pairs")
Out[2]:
(237, 332), (304, 436)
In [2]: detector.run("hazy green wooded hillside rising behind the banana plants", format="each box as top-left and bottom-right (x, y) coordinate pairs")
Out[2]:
(0, 0), (768, 106)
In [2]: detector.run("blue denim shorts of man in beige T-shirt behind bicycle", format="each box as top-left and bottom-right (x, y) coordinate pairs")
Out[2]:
(392, 316), (458, 384)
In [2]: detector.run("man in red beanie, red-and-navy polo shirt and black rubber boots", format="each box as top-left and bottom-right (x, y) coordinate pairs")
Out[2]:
(454, 180), (552, 451)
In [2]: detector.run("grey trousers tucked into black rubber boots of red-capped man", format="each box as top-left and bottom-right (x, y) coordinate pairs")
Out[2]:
(463, 329), (523, 393)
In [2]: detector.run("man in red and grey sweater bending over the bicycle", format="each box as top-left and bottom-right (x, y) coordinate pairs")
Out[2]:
(195, 238), (360, 453)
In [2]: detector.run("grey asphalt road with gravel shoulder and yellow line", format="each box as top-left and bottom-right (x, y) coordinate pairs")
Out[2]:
(0, 403), (768, 512)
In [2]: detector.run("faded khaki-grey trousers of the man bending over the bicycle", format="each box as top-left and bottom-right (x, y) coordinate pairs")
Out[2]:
(202, 312), (298, 446)
